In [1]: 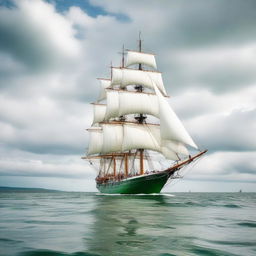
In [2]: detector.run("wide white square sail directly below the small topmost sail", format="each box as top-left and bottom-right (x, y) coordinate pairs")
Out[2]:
(111, 68), (167, 96)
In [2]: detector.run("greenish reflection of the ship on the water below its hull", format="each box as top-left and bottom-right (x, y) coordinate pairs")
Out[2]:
(85, 195), (185, 255)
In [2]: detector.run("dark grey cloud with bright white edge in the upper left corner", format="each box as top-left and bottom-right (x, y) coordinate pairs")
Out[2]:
(0, 0), (81, 70)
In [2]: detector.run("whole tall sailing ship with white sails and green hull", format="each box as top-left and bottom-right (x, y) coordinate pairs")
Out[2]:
(82, 39), (207, 194)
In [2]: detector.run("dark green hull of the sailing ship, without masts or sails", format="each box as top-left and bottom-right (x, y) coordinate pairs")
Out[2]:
(97, 172), (170, 194)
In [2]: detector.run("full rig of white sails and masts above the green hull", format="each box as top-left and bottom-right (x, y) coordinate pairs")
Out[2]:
(85, 38), (203, 183)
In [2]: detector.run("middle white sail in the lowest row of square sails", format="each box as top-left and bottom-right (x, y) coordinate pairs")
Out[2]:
(102, 124), (123, 154)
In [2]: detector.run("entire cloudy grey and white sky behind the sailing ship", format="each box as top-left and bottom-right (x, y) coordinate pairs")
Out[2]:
(0, 0), (256, 192)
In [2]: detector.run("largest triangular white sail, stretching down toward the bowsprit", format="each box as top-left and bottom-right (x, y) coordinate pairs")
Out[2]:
(155, 83), (198, 149)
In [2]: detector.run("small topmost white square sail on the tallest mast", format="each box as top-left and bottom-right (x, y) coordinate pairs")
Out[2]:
(126, 51), (157, 69)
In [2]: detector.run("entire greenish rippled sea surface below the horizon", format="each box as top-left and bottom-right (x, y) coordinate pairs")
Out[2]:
(0, 192), (256, 256)
